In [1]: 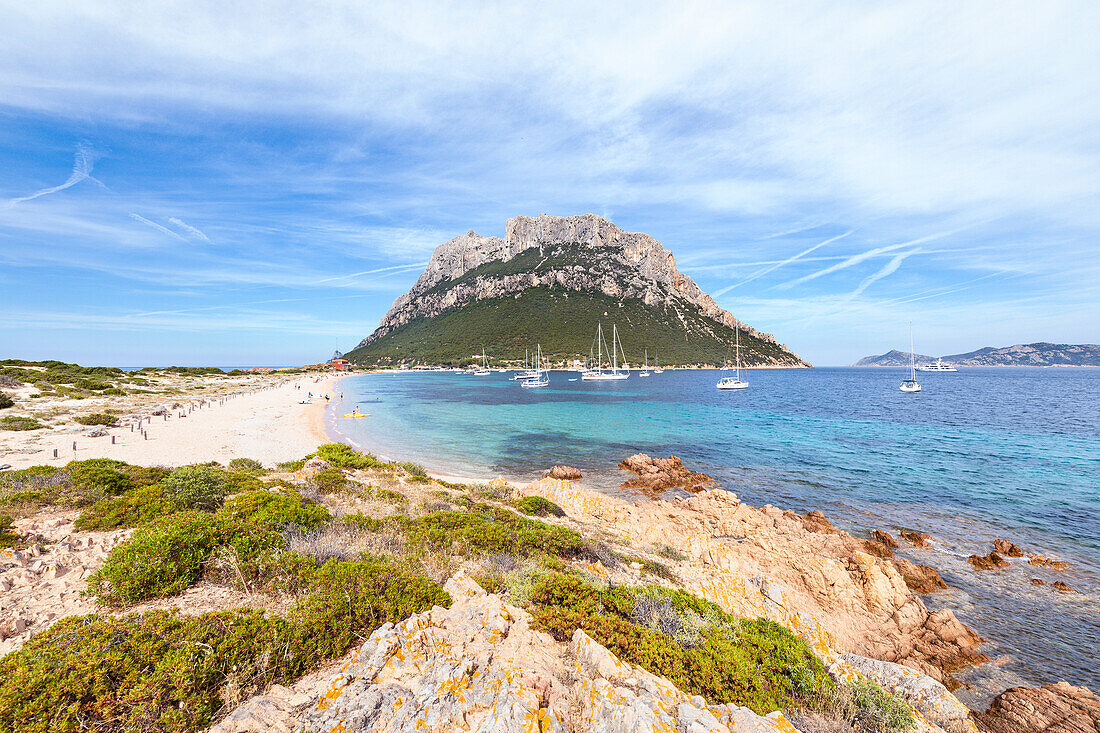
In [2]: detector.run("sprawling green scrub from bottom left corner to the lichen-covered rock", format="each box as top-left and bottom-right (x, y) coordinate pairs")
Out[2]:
(0, 559), (450, 733)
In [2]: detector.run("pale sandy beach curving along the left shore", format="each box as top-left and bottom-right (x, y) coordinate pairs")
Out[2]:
(0, 378), (337, 469)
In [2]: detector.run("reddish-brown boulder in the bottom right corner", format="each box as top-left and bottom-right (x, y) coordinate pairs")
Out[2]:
(976, 682), (1100, 733)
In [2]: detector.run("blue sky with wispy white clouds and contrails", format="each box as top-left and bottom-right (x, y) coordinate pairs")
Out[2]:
(0, 0), (1100, 365)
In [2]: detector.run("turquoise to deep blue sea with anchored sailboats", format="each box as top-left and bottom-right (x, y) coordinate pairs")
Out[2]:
(328, 368), (1100, 709)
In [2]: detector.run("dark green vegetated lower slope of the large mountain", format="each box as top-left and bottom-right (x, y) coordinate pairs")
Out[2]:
(344, 286), (798, 367)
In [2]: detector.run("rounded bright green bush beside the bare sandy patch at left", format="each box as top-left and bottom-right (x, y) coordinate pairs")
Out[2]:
(88, 512), (223, 606)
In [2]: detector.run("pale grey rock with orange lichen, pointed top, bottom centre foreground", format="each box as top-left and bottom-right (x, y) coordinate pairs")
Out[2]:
(223, 571), (809, 733)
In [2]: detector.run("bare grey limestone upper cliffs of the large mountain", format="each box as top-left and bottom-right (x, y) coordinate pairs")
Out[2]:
(360, 214), (804, 365)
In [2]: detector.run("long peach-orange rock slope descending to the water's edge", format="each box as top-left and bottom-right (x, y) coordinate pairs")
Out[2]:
(526, 471), (988, 689)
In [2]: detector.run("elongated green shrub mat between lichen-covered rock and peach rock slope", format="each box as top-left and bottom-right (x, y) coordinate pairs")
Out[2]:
(530, 573), (834, 714)
